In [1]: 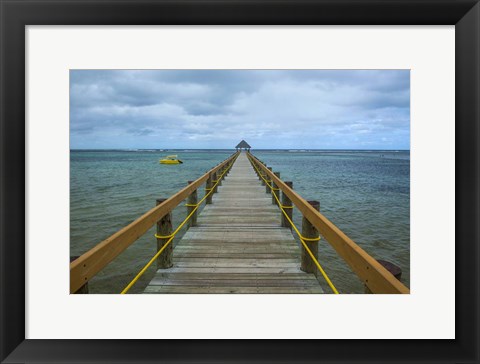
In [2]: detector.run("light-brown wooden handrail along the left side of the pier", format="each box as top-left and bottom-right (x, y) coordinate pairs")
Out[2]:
(70, 152), (238, 293)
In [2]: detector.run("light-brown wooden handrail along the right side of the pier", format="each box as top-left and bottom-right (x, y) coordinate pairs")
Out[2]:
(249, 153), (410, 293)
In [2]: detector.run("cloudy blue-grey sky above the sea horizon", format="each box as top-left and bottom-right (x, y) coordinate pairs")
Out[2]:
(70, 70), (410, 149)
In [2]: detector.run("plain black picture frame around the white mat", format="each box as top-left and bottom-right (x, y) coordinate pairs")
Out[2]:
(0, 0), (480, 363)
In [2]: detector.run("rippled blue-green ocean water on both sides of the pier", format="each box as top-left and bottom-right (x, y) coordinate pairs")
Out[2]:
(70, 150), (410, 293)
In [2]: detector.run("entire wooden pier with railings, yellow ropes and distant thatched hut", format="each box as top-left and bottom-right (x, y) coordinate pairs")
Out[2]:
(70, 141), (410, 294)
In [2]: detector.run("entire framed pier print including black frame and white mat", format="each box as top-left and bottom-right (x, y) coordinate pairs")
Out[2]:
(0, 0), (480, 363)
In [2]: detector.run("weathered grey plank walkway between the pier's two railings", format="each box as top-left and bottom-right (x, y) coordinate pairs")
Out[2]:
(144, 153), (323, 293)
